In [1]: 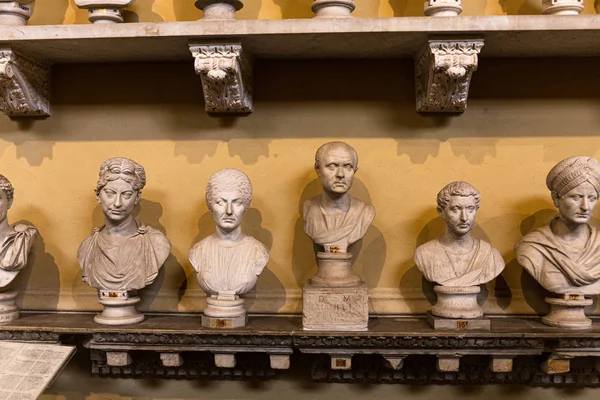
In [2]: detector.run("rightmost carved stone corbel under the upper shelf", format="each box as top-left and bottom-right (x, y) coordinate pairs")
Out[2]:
(415, 39), (483, 112)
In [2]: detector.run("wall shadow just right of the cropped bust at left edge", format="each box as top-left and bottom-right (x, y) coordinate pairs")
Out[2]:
(12, 220), (60, 310)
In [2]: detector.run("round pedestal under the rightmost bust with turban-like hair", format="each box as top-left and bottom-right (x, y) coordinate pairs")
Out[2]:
(542, 295), (593, 329)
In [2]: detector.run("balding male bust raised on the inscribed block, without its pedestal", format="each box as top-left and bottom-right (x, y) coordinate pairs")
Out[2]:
(303, 142), (375, 253)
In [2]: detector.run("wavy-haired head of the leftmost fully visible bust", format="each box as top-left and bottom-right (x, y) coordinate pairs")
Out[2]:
(95, 157), (146, 222)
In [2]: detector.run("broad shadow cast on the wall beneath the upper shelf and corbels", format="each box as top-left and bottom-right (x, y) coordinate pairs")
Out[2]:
(0, 57), (600, 165)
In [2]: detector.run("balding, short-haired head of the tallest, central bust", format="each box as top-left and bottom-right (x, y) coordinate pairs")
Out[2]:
(315, 142), (358, 195)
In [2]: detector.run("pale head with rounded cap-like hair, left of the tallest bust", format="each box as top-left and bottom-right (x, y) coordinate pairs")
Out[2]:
(206, 168), (252, 232)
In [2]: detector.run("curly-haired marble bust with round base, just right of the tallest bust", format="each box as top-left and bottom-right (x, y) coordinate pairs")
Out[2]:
(414, 181), (505, 322)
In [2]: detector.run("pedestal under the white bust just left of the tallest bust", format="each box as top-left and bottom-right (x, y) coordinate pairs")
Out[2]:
(202, 293), (248, 328)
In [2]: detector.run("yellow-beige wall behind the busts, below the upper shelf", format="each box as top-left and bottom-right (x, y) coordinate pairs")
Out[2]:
(0, 58), (600, 314)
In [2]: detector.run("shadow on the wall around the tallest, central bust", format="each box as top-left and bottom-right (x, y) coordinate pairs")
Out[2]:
(292, 178), (386, 296)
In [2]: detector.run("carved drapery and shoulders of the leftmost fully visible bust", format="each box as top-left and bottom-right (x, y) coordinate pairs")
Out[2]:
(77, 220), (171, 290)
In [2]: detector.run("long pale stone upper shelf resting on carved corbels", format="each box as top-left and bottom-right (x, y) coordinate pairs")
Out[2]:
(0, 15), (600, 63)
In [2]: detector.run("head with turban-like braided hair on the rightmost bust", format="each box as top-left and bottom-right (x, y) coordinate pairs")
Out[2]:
(546, 156), (600, 226)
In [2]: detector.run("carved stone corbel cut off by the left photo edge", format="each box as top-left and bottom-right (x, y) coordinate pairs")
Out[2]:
(0, 48), (50, 117)
